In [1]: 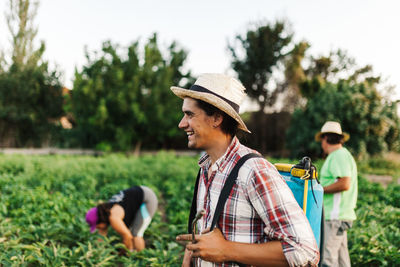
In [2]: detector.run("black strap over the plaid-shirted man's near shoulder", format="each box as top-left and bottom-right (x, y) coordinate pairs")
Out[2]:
(210, 153), (261, 231)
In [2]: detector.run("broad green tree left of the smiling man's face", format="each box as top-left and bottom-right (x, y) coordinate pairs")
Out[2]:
(70, 34), (191, 153)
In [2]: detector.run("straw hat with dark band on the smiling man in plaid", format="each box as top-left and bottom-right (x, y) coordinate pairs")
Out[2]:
(171, 73), (250, 133)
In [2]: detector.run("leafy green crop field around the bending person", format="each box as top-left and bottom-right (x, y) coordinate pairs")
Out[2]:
(0, 153), (400, 266)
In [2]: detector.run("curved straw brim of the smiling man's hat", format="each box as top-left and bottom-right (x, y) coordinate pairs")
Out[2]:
(171, 86), (251, 133)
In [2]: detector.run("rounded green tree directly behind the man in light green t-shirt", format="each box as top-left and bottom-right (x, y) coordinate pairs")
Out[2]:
(286, 80), (400, 157)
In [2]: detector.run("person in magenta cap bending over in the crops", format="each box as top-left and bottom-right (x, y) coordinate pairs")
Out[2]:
(86, 186), (158, 251)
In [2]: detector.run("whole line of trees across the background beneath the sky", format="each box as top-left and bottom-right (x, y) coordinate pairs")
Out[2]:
(0, 0), (400, 157)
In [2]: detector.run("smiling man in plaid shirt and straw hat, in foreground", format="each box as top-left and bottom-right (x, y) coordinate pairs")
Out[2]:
(171, 74), (319, 266)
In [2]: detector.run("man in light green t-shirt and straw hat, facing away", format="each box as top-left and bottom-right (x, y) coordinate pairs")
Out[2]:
(315, 121), (357, 267)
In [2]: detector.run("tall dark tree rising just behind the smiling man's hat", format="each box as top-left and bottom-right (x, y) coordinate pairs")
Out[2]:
(228, 21), (293, 112)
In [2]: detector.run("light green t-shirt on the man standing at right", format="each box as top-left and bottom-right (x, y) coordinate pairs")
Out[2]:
(320, 147), (358, 220)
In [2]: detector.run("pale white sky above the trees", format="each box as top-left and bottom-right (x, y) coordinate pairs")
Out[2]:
(0, 0), (400, 99)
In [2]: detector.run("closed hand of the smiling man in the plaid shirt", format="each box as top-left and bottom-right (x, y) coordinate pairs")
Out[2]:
(176, 228), (229, 262)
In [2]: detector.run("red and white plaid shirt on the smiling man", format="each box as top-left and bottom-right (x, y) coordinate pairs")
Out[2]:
(196, 137), (319, 267)
